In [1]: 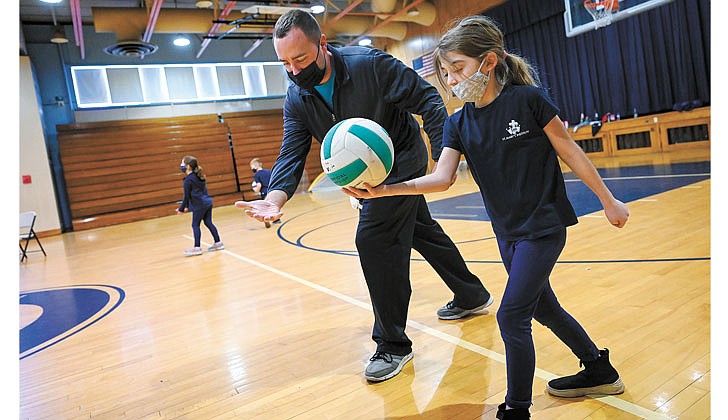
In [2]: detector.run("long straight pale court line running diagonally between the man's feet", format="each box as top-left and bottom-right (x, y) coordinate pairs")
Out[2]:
(189, 235), (671, 420)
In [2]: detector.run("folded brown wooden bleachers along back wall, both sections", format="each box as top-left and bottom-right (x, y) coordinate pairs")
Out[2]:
(58, 110), (321, 230)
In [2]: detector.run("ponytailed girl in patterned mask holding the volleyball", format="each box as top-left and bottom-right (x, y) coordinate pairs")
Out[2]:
(344, 16), (629, 419)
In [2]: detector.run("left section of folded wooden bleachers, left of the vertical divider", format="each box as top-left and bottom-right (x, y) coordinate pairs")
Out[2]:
(58, 115), (239, 229)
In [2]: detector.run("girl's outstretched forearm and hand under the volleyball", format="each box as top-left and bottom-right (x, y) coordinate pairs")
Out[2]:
(342, 147), (460, 198)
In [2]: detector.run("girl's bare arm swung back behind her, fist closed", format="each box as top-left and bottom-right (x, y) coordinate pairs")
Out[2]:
(544, 116), (629, 228)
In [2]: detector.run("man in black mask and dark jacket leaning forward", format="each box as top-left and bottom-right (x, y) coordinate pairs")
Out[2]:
(235, 10), (493, 382)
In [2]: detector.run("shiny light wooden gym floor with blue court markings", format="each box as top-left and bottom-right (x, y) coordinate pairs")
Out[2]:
(19, 149), (711, 419)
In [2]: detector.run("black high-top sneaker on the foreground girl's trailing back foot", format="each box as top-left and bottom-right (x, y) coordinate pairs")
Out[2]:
(546, 349), (624, 398)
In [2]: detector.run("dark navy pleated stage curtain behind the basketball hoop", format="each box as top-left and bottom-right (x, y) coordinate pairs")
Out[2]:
(483, 0), (710, 123)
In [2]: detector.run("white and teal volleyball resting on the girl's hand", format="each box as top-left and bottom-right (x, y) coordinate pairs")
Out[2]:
(321, 118), (394, 188)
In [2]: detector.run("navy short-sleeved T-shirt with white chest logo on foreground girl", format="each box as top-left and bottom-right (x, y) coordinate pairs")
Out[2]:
(443, 84), (578, 241)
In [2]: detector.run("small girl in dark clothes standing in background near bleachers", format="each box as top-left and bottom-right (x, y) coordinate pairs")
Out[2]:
(177, 156), (225, 256)
